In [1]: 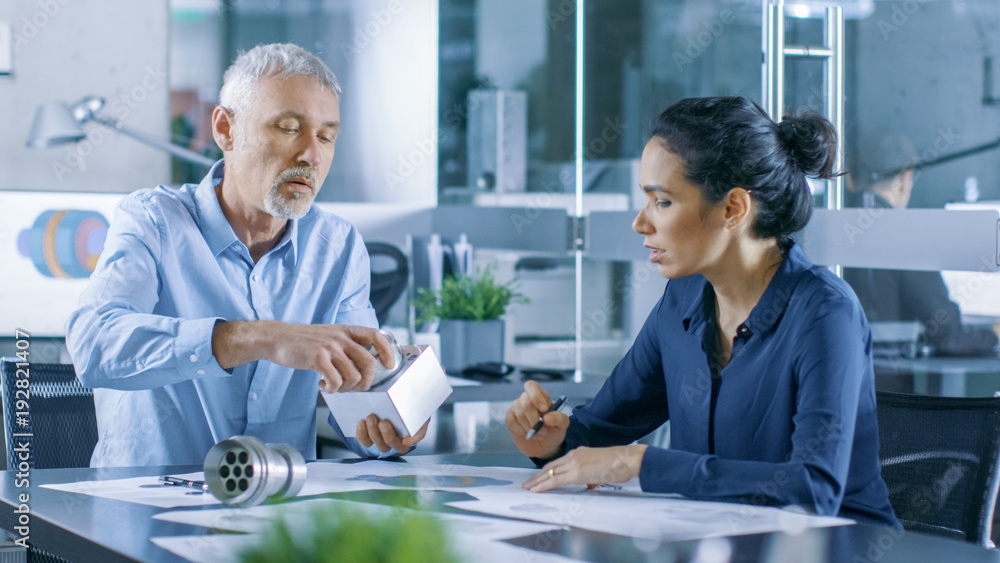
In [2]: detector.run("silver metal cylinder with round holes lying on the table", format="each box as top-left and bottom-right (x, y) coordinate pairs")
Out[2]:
(204, 436), (306, 507)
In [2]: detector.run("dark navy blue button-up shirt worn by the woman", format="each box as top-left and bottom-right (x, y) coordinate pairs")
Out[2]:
(566, 245), (898, 526)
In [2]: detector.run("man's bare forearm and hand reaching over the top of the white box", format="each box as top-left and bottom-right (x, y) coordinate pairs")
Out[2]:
(212, 321), (394, 393)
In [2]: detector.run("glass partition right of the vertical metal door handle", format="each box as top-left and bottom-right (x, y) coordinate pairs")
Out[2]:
(844, 1), (1000, 396)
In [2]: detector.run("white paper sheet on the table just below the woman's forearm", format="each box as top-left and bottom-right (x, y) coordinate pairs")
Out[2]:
(446, 491), (853, 541)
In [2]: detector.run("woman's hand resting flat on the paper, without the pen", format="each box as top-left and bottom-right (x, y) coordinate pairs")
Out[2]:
(521, 444), (646, 493)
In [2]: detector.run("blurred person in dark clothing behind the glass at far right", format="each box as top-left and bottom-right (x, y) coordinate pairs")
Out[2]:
(844, 134), (997, 360)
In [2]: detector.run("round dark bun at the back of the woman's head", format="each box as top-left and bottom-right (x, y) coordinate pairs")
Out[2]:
(778, 111), (837, 178)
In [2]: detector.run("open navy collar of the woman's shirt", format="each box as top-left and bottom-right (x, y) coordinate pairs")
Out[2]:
(683, 243), (813, 336)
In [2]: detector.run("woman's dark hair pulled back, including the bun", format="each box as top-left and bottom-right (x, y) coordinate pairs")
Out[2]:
(650, 97), (837, 252)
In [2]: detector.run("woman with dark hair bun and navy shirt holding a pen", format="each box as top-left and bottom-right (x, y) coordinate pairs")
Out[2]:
(506, 98), (899, 526)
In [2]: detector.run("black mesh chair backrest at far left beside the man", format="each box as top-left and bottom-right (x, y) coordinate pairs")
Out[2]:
(0, 358), (97, 469)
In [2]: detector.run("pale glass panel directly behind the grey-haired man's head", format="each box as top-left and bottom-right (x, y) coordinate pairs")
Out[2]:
(171, 0), (438, 207)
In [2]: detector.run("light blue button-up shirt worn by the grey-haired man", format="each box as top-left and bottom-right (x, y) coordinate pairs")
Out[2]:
(67, 161), (378, 467)
